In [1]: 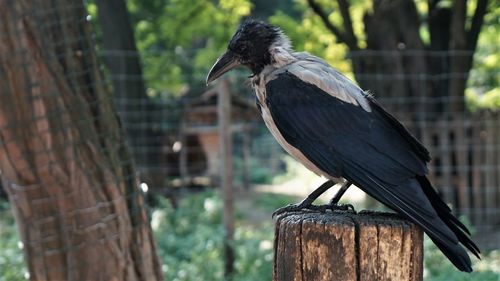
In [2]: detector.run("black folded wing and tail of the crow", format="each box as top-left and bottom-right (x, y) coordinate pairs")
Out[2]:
(266, 72), (479, 271)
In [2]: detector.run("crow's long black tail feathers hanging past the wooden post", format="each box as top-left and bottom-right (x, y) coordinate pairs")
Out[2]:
(348, 165), (479, 272)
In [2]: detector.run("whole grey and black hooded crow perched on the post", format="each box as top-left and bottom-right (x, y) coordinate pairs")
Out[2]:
(207, 20), (480, 272)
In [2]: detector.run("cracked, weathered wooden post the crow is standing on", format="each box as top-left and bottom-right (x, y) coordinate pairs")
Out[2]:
(273, 211), (423, 281)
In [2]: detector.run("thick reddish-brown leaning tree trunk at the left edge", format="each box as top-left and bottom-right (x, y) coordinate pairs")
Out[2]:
(0, 0), (162, 280)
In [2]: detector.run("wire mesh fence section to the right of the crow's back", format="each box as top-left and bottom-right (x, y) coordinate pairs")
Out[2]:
(352, 50), (500, 248)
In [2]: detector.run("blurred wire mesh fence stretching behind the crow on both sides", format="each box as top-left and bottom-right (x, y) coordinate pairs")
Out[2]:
(99, 47), (500, 249)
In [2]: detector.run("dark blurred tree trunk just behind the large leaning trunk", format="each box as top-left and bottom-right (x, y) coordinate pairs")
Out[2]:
(96, 0), (166, 189)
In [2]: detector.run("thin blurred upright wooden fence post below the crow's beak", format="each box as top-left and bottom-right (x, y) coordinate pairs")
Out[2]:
(217, 79), (234, 280)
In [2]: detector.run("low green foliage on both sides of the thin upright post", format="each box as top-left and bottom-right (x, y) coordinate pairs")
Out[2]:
(152, 192), (273, 280)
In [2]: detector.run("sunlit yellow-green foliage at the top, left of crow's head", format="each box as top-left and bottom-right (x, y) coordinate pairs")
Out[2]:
(127, 0), (252, 96)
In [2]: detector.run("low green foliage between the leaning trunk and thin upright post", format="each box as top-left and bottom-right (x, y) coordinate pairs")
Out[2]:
(152, 194), (223, 280)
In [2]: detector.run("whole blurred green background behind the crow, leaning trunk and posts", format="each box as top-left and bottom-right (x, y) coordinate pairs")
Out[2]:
(0, 0), (500, 280)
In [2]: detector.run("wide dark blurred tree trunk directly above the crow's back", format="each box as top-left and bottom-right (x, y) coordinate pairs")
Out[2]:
(353, 0), (436, 117)
